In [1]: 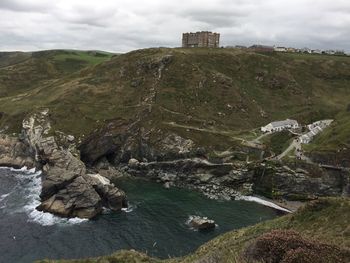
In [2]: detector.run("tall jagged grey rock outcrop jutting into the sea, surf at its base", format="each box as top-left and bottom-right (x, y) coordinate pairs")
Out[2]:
(23, 110), (126, 218)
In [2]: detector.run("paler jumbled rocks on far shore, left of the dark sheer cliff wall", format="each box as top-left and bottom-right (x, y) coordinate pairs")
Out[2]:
(122, 158), (253, 200)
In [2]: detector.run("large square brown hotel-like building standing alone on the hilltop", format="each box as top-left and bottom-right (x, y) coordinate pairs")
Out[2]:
(182, 31), (220, 48)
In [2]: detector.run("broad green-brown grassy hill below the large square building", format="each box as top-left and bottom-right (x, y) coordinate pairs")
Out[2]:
(0, 48), (350, 155)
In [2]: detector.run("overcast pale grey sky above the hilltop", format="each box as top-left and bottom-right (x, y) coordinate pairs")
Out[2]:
(0, 0), (350, 52)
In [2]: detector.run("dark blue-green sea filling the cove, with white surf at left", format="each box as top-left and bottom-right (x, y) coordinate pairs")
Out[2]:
(0, 168), (280, 263)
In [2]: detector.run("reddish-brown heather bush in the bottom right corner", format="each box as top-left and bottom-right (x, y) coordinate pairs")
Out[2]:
(244, 230), (350, 263)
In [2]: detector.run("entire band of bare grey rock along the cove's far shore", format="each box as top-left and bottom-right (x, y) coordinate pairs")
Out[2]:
(0, 110), (350, 221)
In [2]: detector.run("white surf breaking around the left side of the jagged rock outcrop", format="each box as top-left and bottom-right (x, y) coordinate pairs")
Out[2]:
(1, 166), (88, 226)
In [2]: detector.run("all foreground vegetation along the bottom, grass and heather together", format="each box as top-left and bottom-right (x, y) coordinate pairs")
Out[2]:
(39, 198), (350, 263)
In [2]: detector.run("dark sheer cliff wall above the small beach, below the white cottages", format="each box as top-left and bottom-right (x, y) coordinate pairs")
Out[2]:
(253, 163), (350, 200)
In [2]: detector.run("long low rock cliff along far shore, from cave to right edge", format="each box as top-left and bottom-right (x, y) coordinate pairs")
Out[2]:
(122, 154), (350, 201)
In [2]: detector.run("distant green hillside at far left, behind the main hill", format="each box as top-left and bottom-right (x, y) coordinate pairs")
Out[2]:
(0, 50), (113, 132)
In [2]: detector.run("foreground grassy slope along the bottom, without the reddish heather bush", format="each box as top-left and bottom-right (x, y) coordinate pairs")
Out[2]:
(36, 198), (350, 263)
